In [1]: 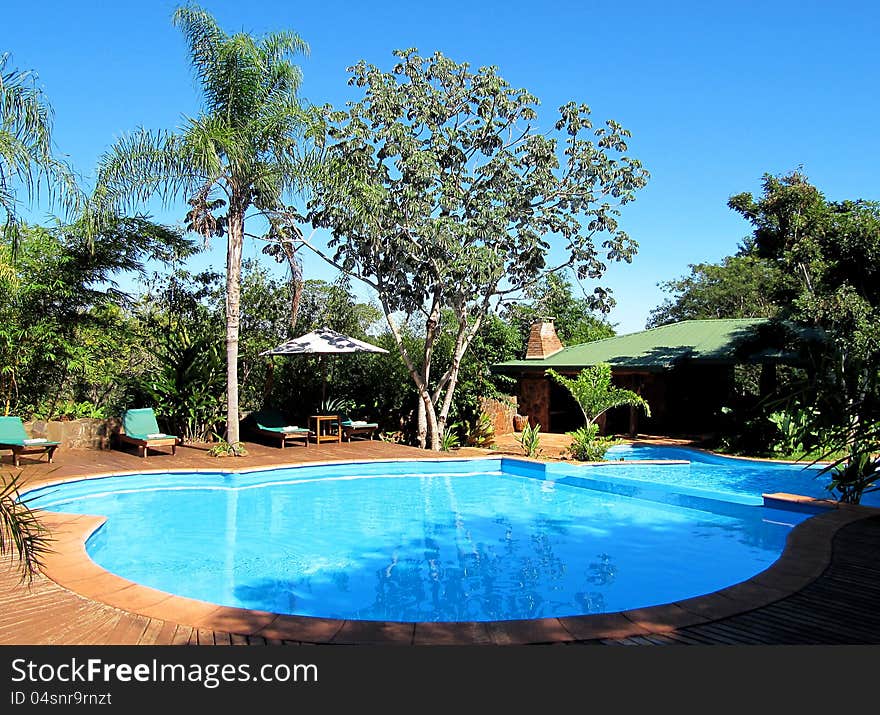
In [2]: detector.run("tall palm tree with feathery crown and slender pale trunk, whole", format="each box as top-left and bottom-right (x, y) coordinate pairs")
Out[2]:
(92, 6), (311, 445)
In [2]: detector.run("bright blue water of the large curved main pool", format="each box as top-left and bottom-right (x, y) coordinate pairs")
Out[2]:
(26, 459), (808, 621)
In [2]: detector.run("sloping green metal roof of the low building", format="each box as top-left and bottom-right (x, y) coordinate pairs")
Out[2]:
(493, 318), (781, 372)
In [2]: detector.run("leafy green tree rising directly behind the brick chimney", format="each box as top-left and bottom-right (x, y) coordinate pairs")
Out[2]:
(505, 273), (614, 357)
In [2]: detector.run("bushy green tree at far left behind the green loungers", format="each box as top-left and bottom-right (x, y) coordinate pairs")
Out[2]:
(0, 218), (191, 418)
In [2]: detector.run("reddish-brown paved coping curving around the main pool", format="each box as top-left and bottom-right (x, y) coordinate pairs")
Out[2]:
(31, 455), (880, 645)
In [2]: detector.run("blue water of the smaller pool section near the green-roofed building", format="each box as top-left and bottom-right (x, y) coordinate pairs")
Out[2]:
(603, 445), (880, 506)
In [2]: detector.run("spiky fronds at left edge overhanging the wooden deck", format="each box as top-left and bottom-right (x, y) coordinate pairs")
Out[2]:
(0, 474), (51, 583)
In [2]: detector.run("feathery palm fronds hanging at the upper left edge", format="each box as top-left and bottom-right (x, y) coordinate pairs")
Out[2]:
(0, 52), (82, 254)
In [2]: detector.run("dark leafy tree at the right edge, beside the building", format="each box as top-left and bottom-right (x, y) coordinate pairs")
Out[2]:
(729, 172), (880, 501)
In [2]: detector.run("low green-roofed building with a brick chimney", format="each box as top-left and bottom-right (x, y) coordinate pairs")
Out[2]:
(493, 318), (801, 434)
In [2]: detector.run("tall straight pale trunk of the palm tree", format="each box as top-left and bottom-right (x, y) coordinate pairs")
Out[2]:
(226, 201), (244, 444)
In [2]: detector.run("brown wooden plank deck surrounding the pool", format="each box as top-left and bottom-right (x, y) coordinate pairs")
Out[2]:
(0, 442), (880, 645)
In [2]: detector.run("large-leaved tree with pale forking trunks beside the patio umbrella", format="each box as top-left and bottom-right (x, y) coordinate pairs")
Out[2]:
(303, 49), (647, 450)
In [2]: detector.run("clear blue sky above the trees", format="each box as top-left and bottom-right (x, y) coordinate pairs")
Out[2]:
(0, 0), (880, 332)
